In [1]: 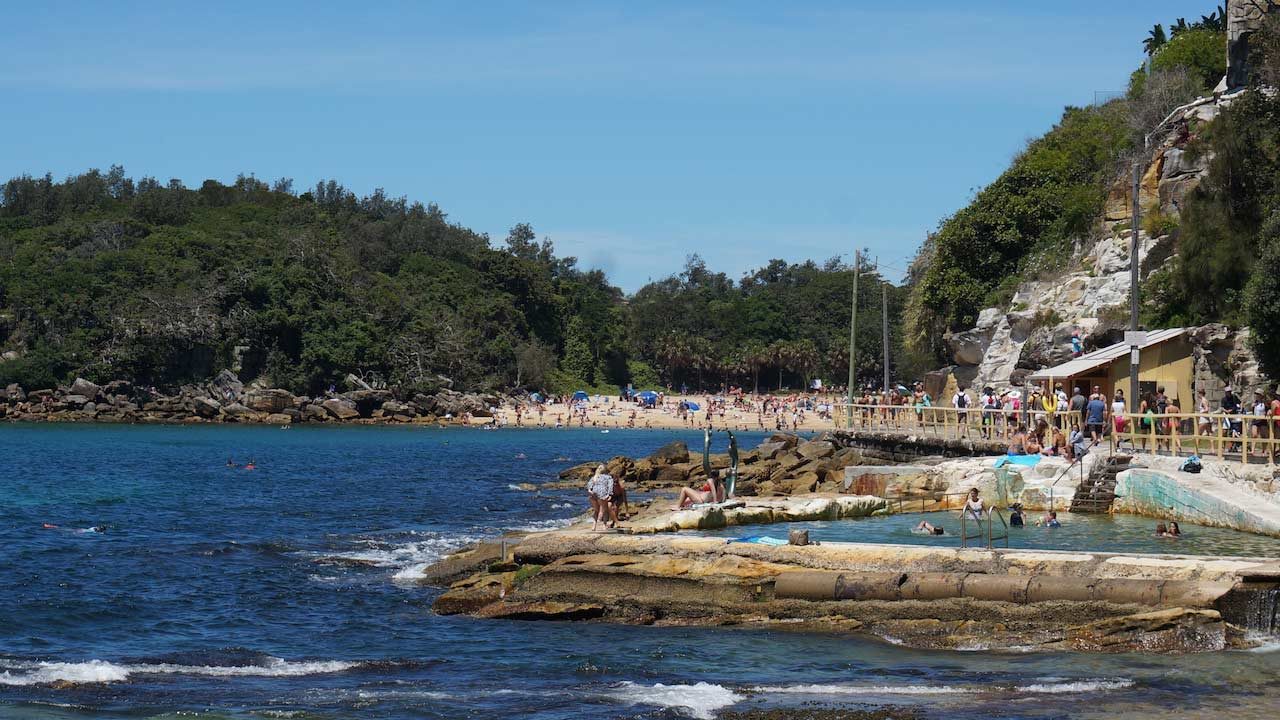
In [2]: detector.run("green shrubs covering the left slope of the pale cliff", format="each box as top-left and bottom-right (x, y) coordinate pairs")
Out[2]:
(906, 102), (1132, 354)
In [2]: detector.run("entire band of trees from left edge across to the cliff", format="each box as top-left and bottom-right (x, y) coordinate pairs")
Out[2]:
(0, 168), (900, 393)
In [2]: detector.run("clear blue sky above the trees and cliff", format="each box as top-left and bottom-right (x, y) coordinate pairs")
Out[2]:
(0, 0), (1217, 291)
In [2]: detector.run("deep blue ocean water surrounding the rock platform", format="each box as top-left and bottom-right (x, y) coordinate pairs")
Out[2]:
(0, 425), (1280, 720)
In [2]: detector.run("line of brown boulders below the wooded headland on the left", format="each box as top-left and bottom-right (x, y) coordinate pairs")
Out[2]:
(0, 370), (503, 425)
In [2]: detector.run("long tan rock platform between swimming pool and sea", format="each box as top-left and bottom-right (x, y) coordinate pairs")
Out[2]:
(435, 520), (1280, 652)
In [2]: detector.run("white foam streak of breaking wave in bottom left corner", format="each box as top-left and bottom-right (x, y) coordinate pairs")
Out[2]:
(0, 657), (360, 685)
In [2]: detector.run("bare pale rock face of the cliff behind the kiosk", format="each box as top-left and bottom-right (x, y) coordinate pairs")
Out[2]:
(945, 96), (1265, 389)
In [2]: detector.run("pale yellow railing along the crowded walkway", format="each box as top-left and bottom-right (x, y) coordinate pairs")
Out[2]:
(832, 404), (1280, 464)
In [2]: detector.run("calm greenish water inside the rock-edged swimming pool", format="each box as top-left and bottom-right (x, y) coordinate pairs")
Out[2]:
(701, 511), (1280, 557)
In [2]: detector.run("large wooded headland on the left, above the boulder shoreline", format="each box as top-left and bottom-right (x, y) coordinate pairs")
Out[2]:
(0, 168), (621, 392)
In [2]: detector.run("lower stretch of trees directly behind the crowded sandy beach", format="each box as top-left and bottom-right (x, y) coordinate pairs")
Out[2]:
(631, 255), (920, 388)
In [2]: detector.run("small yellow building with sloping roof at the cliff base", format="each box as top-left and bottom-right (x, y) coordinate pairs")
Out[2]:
(1027, 328), (1196, 409)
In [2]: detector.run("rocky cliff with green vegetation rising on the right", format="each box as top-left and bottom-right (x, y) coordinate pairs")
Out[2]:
(905, 1), (1280, 386)
